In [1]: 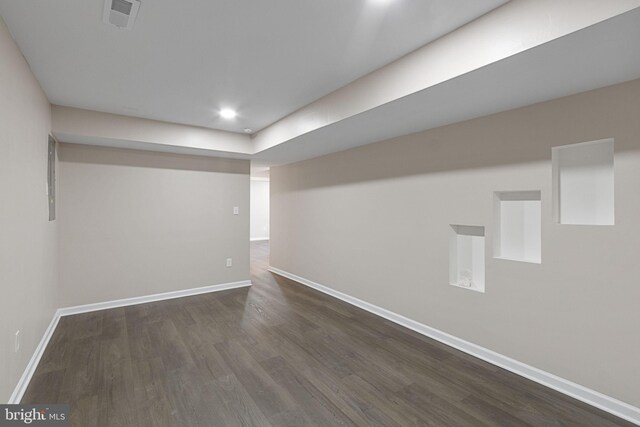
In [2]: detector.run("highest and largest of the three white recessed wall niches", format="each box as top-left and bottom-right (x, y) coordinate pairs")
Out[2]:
(552, 139), (615, 225)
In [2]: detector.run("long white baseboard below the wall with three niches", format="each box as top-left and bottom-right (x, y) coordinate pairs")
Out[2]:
(269, 266), (640, 425)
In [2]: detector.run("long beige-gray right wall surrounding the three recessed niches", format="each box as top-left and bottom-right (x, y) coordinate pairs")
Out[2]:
(270, 80), (640, 406)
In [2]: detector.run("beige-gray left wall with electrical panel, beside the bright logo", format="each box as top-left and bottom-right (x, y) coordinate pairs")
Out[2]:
(0, 19), (58, 402)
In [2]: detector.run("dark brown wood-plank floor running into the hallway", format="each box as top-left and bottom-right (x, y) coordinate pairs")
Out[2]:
(22, 242), (631, 427)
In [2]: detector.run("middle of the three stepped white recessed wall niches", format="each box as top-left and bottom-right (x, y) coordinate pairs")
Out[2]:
(493, 191), (542, 264)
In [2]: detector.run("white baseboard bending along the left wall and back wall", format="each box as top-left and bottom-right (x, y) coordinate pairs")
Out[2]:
(8, 280), (251, 404)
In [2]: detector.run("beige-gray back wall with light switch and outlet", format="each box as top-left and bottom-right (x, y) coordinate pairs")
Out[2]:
(58, 144), (250, 307)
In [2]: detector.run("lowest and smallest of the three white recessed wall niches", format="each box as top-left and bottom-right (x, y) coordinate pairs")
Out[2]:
(449, 224), (484, 292)
